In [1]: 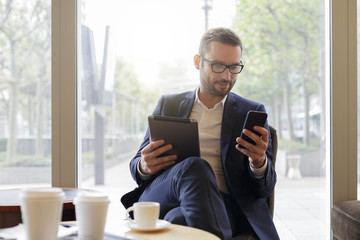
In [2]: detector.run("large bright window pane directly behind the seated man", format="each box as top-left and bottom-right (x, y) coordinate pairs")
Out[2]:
(78, 0), (329, 239)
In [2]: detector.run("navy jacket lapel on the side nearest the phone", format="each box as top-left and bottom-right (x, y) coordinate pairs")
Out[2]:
(220, 93), (237, 162)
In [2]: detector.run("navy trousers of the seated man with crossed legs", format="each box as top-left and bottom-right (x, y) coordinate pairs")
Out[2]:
(139, 157), (232, 240)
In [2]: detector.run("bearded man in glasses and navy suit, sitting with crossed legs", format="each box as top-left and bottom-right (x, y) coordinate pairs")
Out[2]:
(122, 28), (279, 239)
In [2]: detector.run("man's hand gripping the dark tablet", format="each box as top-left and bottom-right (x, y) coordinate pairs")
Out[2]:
(139, 139), (177, 175)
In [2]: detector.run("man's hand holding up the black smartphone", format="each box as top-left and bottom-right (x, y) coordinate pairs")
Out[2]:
(236, 126), (269, 168)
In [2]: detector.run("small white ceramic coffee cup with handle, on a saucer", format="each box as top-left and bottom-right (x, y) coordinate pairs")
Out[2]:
(126, 202), (160, 228)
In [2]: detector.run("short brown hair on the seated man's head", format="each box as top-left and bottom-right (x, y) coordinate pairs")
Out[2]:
(199, 27), (242, 56)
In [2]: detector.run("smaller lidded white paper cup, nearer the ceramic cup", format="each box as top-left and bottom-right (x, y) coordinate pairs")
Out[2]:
(74, 191), (109, 240)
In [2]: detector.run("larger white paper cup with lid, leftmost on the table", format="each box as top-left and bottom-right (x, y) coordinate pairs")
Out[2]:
(19, 188), (65, 240)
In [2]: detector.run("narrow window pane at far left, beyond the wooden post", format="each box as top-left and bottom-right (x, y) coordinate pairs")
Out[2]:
(0, 0), (51, 188)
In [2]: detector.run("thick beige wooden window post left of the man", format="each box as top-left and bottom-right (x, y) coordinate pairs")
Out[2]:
(51, 0), (78, 187)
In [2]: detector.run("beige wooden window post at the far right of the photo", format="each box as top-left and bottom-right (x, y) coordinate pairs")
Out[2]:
(327, 0), (357, 204)
